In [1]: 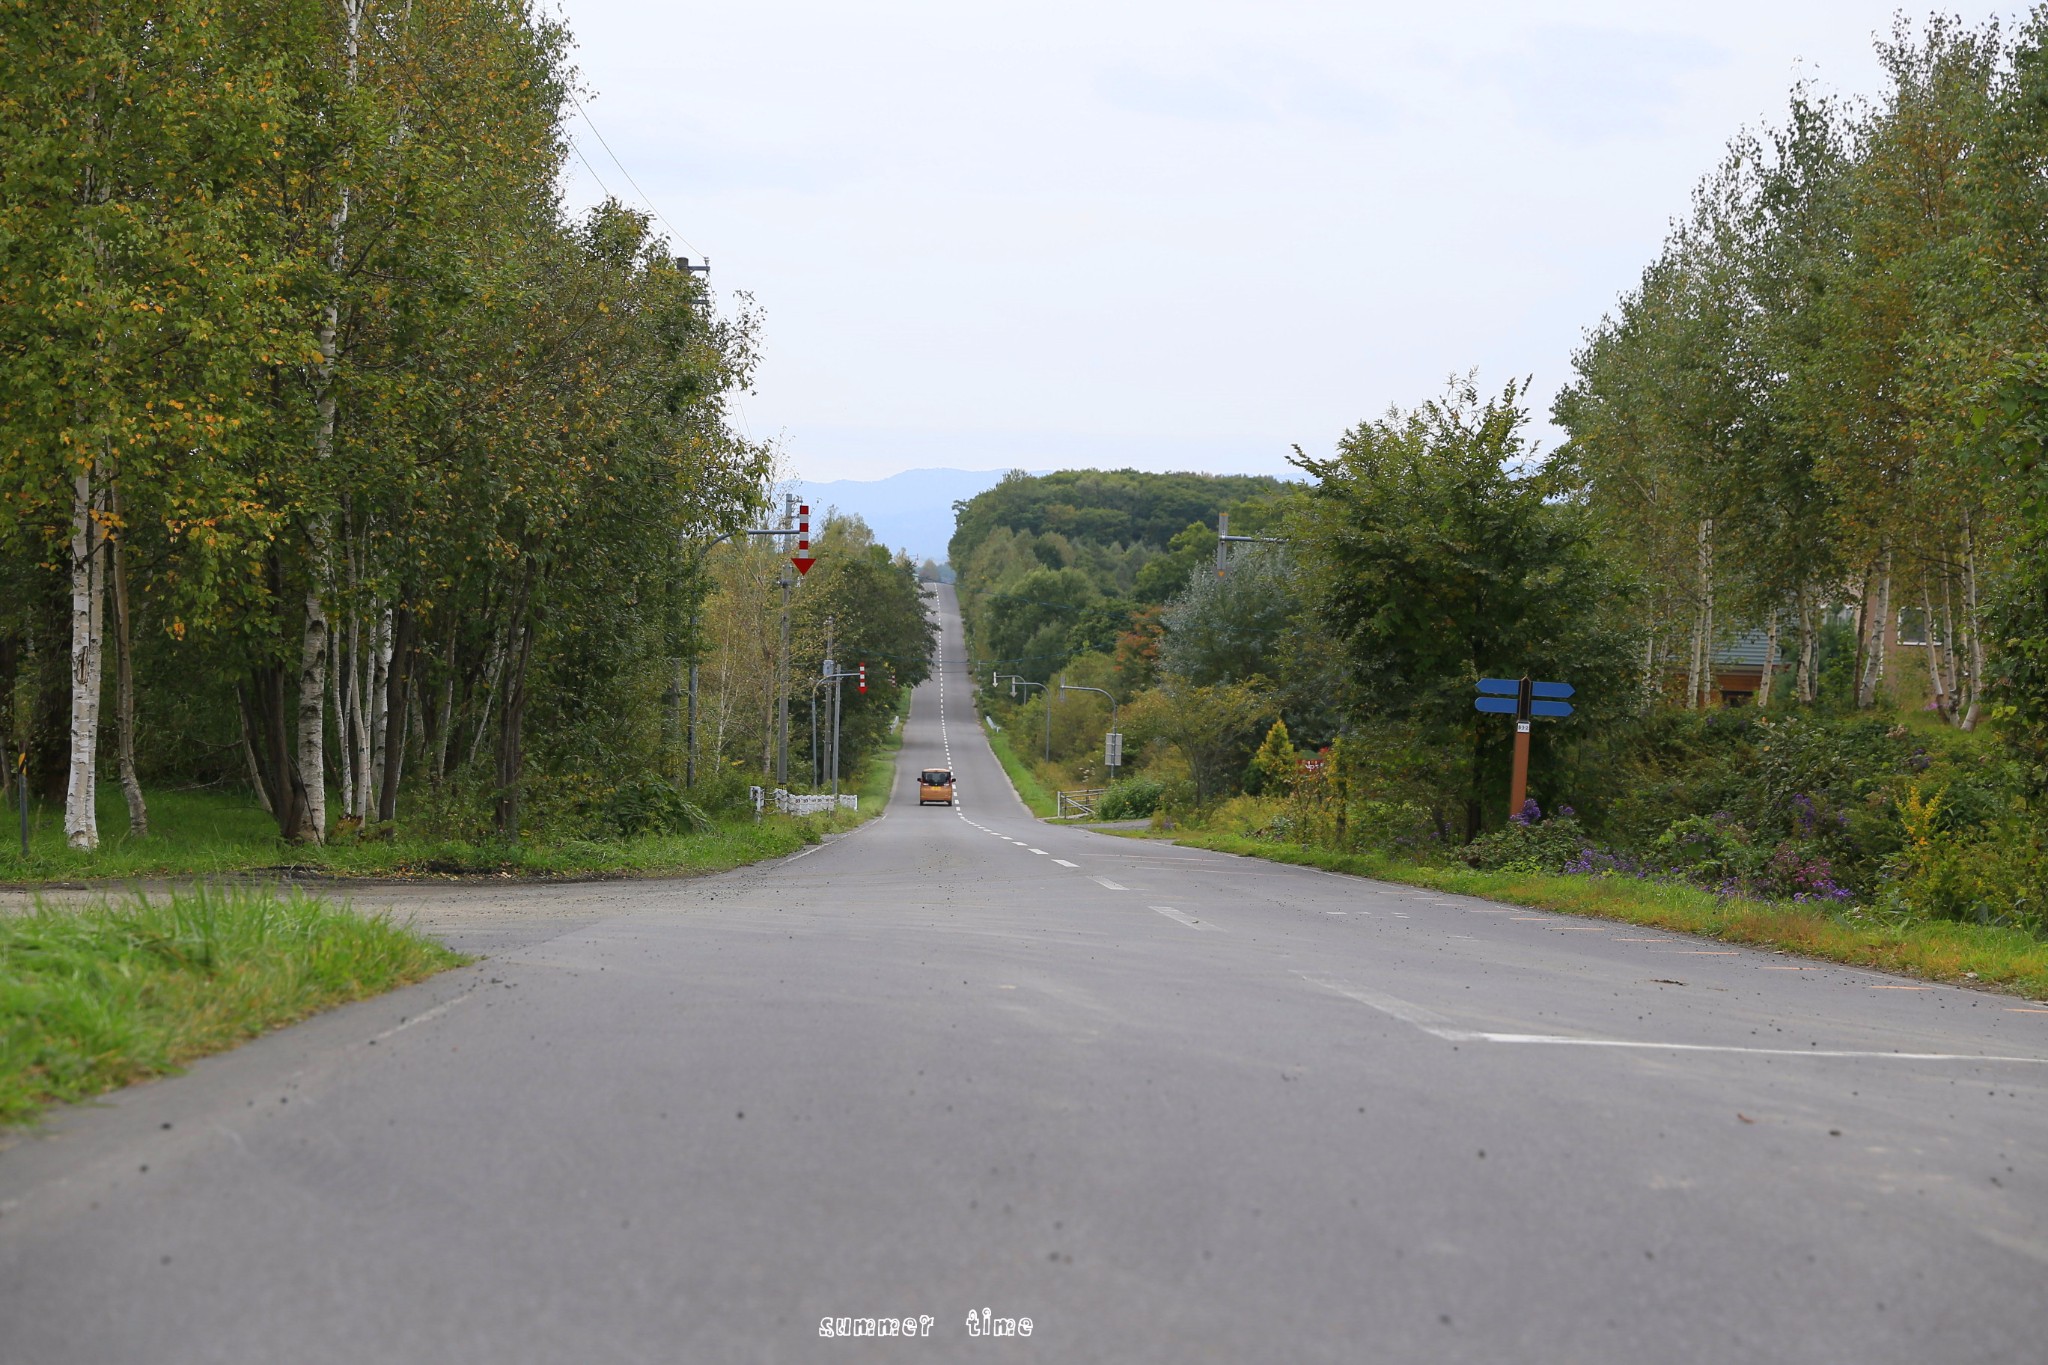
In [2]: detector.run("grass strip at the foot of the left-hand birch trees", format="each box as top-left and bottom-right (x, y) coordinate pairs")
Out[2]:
(0, 724), (901, 884)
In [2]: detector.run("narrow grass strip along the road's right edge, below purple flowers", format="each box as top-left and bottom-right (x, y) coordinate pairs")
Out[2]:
(1174, 831), (2048, 1001)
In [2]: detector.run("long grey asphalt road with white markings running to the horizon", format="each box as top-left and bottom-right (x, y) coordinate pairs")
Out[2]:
(0, 589), (2048, 1365)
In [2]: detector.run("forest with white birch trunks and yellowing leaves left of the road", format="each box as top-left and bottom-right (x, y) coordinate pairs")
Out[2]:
(0, 0), (926, 849)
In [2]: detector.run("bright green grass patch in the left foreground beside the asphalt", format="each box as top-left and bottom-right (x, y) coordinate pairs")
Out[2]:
(0, 886), (469, 1126)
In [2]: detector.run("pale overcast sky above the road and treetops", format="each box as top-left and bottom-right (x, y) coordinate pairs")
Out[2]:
(565, 0), (1989, 481)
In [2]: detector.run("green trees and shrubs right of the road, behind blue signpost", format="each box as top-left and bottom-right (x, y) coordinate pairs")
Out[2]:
(954, 14), (2048, 929)
